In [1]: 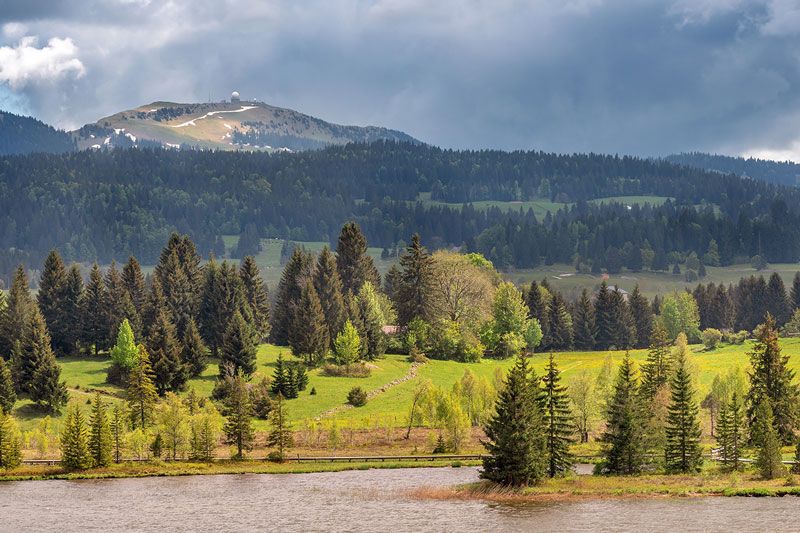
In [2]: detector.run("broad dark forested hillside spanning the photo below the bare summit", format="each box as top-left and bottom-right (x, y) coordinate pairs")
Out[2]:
(0, 142), (800, 274)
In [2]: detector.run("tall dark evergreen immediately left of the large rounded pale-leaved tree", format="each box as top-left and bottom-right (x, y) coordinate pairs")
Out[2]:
(395, 233), (434, 326)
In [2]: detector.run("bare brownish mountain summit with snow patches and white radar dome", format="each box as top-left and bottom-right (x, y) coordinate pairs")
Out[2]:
(75, 101), (418, 151)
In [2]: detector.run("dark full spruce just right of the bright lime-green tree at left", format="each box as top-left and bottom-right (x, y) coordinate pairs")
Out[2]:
(147, 309), (189, 396)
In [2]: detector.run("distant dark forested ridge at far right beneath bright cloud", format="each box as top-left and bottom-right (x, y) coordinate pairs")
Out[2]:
(665, 152), (800, 186)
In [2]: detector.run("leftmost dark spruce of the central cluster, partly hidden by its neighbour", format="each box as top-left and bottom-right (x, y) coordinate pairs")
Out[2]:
(270, 248), (314, 346)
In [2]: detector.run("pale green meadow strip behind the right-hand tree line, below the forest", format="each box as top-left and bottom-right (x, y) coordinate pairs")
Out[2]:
(503, 263), (800, 299)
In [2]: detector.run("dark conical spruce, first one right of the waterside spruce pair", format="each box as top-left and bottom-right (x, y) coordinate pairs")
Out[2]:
(601, 353), (646, 475)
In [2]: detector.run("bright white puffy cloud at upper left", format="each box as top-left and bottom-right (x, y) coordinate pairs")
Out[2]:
(0, 36), (86, 90)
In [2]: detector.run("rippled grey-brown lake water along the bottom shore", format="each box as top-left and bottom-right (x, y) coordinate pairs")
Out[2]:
(0, 468), (800, 533)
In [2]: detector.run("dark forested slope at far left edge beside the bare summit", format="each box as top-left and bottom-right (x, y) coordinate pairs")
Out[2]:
(0, 111), (75, 155)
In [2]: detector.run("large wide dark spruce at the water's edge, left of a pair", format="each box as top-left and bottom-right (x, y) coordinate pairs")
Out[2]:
(480, 355), (547, 486)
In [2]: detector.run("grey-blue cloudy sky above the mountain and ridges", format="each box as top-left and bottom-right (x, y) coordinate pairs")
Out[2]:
(0, 0), (800, 161)
